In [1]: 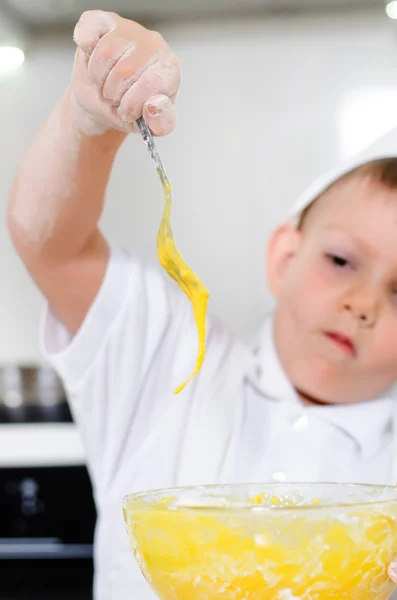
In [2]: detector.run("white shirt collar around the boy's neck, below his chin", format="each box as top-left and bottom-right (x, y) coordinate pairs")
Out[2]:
(247, 316), (396, 458)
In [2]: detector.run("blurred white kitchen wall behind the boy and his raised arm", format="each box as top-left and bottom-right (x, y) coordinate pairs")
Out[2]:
(0, 14), (397, 362)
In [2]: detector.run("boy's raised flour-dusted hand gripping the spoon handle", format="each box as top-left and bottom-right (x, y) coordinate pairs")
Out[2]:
(70, 10), (180, 135)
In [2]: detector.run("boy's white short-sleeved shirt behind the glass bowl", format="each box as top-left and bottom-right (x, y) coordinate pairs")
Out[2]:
(42, 248), (394, 600)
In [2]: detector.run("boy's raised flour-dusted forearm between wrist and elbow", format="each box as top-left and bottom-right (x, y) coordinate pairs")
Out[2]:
(8, 91), (126, 263)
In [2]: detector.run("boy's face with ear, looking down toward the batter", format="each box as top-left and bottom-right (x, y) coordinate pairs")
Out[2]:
(268, 175), (397, 404)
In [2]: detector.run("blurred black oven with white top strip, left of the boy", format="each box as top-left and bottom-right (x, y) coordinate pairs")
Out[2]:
(0, 364), (96, 600)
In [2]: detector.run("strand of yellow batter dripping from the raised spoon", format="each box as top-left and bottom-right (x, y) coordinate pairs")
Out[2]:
(157, 183), (209, 394)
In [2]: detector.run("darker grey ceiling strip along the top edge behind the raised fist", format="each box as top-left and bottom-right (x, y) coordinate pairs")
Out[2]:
(0, 0), (384, 29)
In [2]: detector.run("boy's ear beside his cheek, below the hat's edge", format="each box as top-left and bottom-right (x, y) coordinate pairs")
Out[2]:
(266, 225), (302, 298)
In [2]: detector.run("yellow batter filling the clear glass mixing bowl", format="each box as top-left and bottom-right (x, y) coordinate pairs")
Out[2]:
(124, 497), (397, 600)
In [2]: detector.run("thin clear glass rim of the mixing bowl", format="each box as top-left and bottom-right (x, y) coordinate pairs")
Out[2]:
(123, 481), (397, 514)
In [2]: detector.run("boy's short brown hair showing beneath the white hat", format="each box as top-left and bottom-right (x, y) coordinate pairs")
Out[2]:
(298, 157), (397, 229)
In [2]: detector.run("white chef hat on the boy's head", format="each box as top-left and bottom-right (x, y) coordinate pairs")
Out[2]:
(289, 128), (397, 220)
